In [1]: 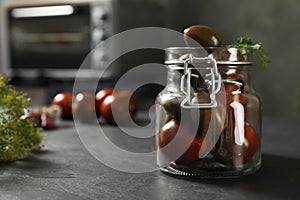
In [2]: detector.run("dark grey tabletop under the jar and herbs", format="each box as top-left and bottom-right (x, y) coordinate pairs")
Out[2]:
(0, 117), (300, 200)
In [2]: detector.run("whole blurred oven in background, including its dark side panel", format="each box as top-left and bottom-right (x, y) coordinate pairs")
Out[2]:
(0, 0), (171, 80)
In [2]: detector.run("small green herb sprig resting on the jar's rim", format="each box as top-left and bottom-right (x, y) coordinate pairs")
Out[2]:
(228, 37), (271, 71)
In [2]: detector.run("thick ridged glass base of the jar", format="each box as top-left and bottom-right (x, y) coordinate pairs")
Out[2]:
(160, 161), (261, 179)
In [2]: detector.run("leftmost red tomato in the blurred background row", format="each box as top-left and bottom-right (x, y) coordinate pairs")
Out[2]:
(52, 92), (73, 119)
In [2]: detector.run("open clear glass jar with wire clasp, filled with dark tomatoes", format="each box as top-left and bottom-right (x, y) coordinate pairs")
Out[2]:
(156, 47), (261, 178)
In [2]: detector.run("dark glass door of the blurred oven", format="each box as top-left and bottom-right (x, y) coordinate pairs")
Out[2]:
(9, 5), (90, 69)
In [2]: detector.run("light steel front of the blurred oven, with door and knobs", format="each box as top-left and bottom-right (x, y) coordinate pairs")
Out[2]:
(2, 0), (117, 78)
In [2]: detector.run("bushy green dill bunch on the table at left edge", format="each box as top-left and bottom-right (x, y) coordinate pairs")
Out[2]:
(0, 74), (46, 162)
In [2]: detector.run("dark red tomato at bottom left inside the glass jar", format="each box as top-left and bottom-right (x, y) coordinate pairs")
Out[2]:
(158, 119), (203, 165)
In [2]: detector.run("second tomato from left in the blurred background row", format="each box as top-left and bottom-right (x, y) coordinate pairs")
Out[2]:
(74, 92), (96, 123)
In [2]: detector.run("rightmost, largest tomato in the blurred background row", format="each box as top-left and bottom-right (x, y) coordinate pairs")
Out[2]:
(100, 91), (138, 124)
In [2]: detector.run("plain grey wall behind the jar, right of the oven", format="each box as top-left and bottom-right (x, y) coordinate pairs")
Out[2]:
(170, 0), (300, 116)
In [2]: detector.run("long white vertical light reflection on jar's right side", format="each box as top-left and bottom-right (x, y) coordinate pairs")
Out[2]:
(230, 101), (245, 146)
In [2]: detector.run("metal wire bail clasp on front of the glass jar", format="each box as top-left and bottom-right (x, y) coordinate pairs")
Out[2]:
(180, 54), (222, 108)
